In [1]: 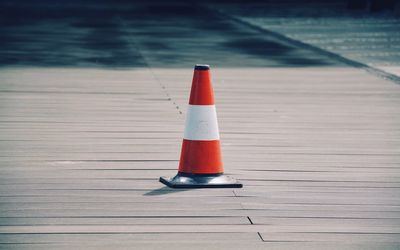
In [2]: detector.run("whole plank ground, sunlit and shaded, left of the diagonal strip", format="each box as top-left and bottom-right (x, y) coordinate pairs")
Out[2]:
(0, 2), (400, 249)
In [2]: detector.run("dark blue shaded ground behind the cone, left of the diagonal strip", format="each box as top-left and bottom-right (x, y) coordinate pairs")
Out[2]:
(0, 1), (346, 67)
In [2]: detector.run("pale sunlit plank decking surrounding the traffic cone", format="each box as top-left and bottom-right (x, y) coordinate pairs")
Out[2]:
(0, 65), (400, 249)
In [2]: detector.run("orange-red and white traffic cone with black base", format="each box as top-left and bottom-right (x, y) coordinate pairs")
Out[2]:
(160, 64), (242, 188)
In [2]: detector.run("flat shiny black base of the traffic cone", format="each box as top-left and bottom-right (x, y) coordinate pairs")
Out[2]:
(160, 173), (243, 188)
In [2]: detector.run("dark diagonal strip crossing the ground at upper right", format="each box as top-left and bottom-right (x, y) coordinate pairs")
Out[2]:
(208, 6), (400, 84)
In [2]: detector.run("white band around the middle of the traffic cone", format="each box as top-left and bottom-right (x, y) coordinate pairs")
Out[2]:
(183, 105), (219, 141)
